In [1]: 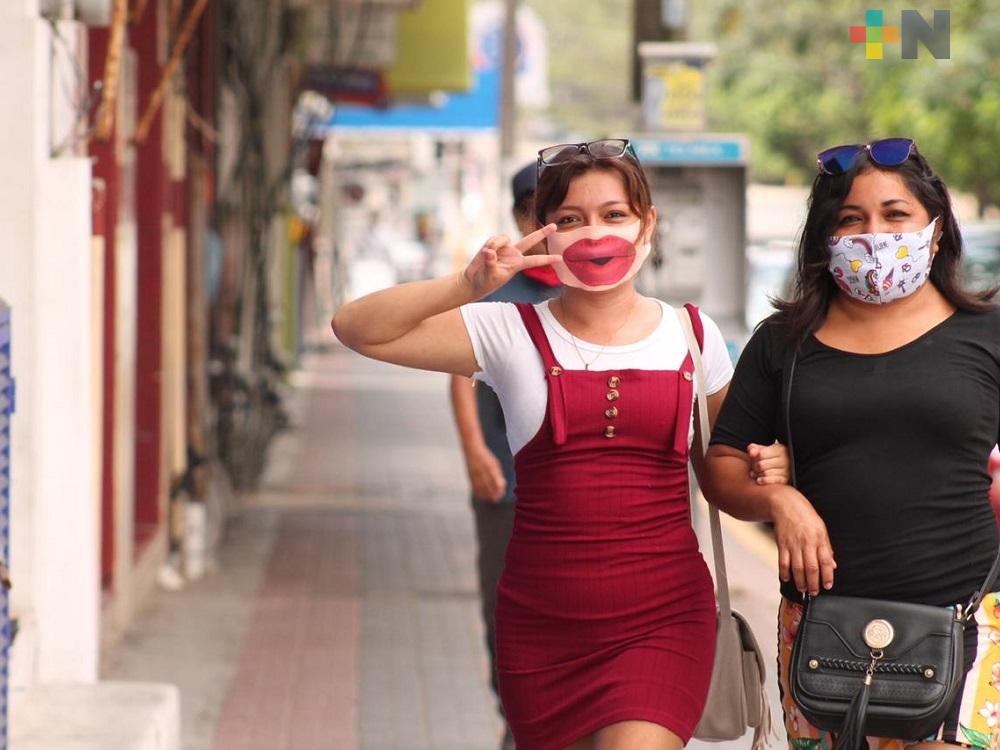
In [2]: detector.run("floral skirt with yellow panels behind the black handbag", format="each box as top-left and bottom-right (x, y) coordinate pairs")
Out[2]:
(778, 592), (1000, 750)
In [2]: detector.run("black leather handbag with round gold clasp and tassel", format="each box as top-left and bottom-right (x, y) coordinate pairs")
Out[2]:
(783, 352), (1000, 750)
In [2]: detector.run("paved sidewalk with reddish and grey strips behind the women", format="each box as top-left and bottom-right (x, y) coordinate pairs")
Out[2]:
(103, 347), (778, 750)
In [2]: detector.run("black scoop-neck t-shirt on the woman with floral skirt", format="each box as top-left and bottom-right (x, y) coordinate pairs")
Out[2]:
(712, 309), (1000, 605)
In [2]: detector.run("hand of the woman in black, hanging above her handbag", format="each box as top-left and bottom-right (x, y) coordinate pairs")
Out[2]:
(771, 485), (837, 596)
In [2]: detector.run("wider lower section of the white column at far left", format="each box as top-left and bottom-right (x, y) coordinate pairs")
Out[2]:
(34, 158), (102, 682)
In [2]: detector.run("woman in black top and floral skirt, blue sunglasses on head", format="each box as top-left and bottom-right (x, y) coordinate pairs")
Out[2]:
(705, 138), (1000, 750)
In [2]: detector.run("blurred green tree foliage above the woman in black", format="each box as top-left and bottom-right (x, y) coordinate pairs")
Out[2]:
(692, 0), (1000, 212)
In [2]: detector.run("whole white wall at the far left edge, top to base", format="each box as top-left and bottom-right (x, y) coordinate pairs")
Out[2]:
(0, 7), (101, 685)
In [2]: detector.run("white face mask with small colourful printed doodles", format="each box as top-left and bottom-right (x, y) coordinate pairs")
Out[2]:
(829, 219), (937, 304)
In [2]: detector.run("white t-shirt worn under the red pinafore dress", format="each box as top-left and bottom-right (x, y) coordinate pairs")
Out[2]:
(460, 300), (733, 455)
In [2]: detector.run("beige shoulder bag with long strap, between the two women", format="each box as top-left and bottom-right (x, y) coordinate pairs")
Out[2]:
(677, 309), (772, 750)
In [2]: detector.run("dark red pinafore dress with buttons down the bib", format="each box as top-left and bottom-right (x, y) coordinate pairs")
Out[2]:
(496, 304), (715, 750)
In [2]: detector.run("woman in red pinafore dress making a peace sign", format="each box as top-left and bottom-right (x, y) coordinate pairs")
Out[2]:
(333, 139), (787, 750)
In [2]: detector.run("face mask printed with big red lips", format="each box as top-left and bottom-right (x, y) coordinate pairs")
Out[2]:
(546, 219), (649, 292)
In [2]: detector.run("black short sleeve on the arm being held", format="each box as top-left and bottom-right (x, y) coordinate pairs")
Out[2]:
(711, 322), (781, 451)
